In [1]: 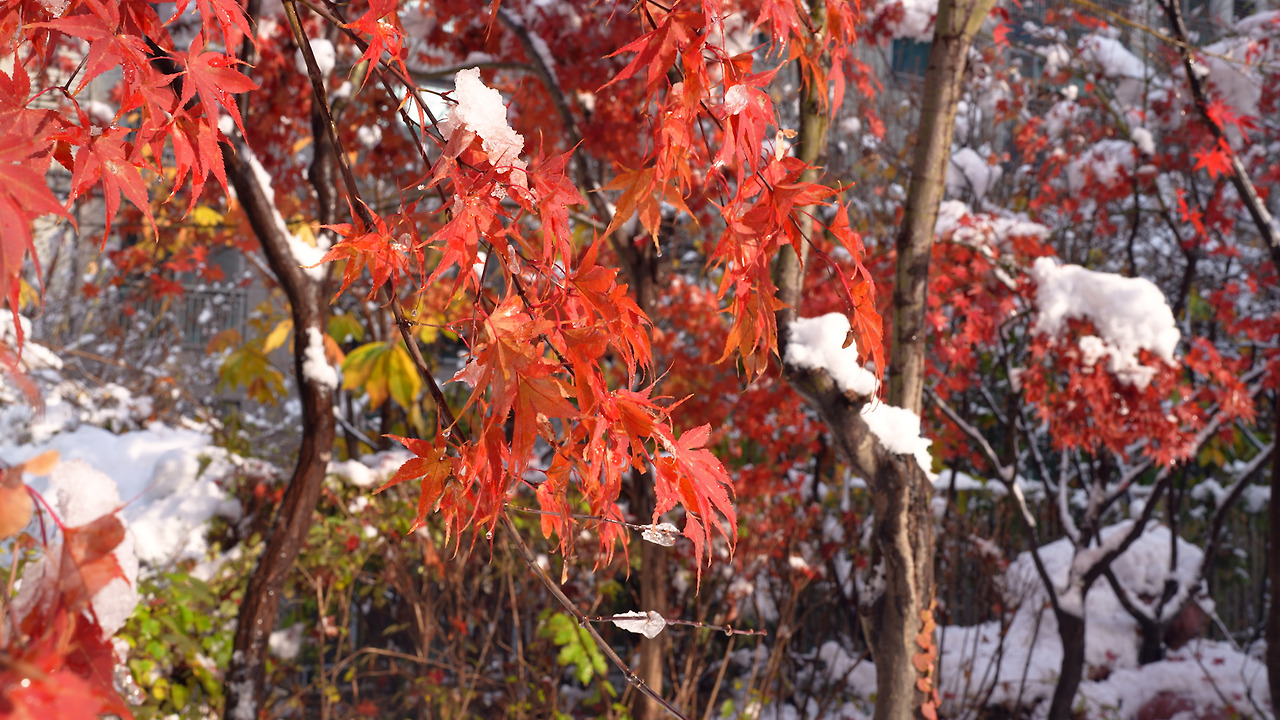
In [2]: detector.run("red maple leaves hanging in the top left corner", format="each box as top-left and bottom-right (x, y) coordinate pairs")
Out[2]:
(0, 0), (257, 343)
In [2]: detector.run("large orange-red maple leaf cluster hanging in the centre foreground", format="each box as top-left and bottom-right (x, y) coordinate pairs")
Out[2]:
(298, 3), (884, 565)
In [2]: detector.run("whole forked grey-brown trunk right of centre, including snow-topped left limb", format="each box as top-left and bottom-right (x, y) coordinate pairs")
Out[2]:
(774, 0), (995, 720)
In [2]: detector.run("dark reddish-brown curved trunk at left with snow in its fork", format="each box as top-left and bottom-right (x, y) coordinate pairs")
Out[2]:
(223, 79), (338, 720)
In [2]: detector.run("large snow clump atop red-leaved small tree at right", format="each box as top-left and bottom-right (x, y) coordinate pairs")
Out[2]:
(1030, 258), (1181, 389)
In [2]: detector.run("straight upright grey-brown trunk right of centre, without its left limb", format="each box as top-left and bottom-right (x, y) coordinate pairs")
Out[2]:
(864, 0), (993, 720)
